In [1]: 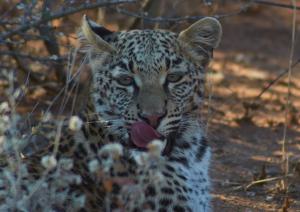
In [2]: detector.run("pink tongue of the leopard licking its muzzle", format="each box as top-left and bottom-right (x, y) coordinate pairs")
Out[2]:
(130, 122), (161, 148)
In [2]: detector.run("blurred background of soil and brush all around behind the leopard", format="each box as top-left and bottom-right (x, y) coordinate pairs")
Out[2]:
(0, 0), (300, 211)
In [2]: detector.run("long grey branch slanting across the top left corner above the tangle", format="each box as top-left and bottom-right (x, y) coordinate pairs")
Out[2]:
(0, 0), (136, 43)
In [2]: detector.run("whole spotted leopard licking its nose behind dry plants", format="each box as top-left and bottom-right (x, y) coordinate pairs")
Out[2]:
(19, 16), (222, 212)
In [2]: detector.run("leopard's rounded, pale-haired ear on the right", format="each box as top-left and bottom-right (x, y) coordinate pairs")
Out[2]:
(178, 17), (222, 66)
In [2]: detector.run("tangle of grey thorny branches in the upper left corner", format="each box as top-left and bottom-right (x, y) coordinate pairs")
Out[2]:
(0, 0), (136, 84)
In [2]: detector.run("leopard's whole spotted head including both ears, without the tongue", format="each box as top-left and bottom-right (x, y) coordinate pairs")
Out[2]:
(82, 17), (222, 152)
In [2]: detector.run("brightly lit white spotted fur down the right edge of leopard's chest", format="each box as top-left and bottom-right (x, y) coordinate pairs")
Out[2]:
(175, 121), (211, 212)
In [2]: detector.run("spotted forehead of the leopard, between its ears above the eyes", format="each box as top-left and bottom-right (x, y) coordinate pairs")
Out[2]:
(114, 30), (179, 73)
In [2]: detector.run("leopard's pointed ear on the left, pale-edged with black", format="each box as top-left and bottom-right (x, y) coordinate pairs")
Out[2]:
(80, 15), (116, 53)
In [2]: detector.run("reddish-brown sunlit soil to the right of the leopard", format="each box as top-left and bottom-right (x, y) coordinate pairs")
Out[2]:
(208, 4), (300, 212)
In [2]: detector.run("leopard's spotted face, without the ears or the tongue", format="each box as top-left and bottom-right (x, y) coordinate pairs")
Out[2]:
(92, 30), (200, 136)
